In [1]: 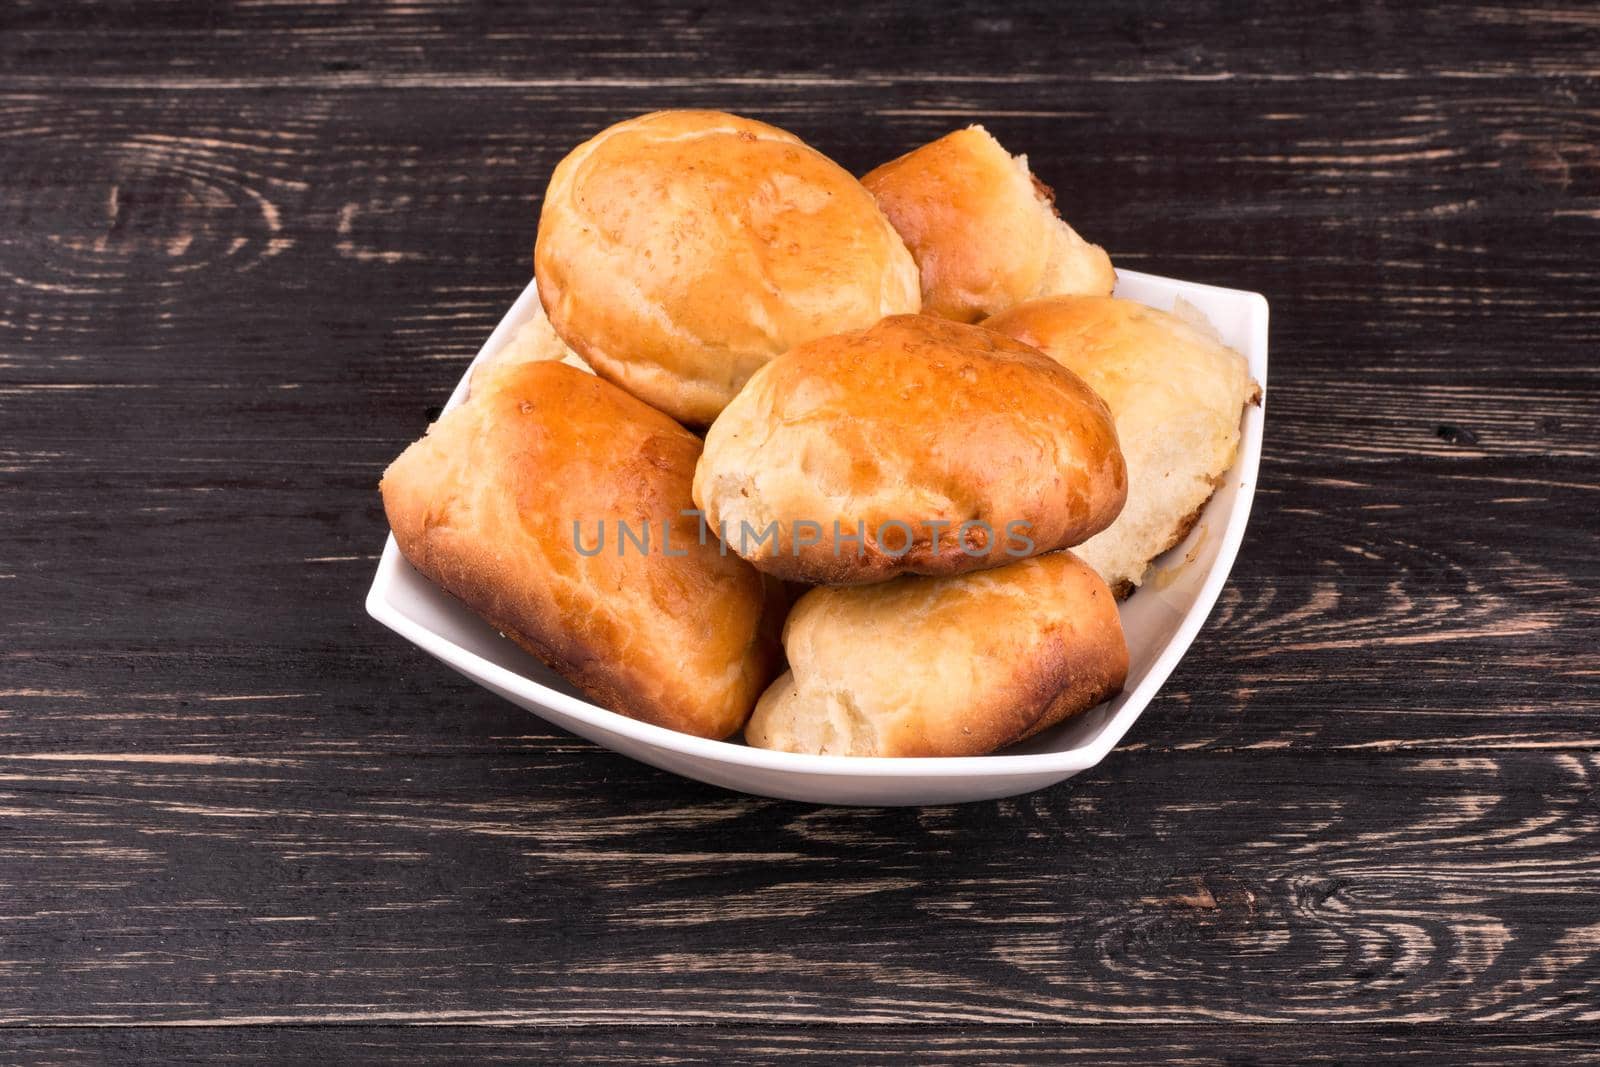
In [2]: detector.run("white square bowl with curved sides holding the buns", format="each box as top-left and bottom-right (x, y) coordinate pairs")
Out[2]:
(366, 270), (1267, 805)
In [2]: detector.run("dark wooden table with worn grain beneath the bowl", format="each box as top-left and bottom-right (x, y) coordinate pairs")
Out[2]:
(0, 0), (1600, 1064)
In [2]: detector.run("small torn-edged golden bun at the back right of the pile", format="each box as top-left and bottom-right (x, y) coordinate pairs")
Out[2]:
(861, 126), (1117, 322)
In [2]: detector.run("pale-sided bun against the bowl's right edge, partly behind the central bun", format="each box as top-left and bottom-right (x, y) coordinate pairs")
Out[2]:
(984, 296), (1261, 597)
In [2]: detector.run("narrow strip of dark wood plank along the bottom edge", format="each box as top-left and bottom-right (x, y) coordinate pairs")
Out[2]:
(11, 1024), (1592, 1067)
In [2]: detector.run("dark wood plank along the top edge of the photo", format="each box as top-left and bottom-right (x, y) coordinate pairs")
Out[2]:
(0, 0), (1595, 83)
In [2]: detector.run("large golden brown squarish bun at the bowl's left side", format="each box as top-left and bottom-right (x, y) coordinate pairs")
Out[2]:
(381, 362), (778, 737)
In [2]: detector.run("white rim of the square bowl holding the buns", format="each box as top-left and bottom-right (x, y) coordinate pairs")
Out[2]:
(366, 269), (1269, 777)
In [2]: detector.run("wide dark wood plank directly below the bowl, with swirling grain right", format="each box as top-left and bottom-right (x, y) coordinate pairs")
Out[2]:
(0, 749), (1600, 1027)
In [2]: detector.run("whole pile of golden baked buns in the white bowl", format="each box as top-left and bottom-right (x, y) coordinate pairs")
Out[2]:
(381, 110), (1258, 757)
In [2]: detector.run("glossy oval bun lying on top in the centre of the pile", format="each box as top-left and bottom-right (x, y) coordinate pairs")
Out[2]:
(694, 315), (1126, 584)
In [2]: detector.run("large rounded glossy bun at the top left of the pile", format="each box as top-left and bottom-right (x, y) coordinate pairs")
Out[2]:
(533, 110), (920, 426)
